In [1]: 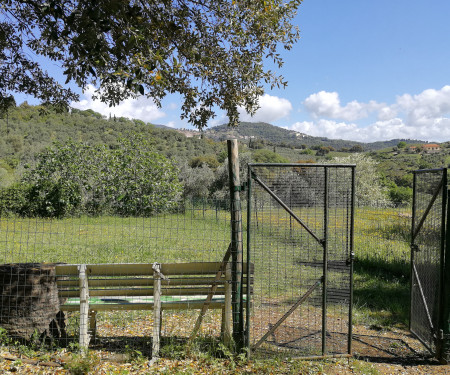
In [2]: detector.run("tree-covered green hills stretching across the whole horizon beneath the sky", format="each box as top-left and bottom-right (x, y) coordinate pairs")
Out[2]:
(0, 103), (450, 197)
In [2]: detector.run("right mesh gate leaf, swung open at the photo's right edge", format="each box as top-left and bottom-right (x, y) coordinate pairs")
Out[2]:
(410, 168), (449, 358)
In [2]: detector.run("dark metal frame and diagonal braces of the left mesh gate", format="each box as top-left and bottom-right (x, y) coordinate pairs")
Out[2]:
(245, 163), (356, 359)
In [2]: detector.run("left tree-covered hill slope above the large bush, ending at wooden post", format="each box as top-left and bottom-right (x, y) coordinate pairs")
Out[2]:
(0, 104), (226, 167)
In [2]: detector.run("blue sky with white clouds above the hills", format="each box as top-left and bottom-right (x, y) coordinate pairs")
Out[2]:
(16, 0), (450, 142)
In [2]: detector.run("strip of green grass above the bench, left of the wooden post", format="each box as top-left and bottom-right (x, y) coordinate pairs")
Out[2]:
(0, 209), (230, 263)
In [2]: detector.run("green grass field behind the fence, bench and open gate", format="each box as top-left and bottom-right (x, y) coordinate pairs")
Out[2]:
(0, 206), (410, 330)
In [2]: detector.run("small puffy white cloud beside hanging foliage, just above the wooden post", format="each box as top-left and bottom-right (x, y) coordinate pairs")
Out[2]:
(239, 94), (292, 123)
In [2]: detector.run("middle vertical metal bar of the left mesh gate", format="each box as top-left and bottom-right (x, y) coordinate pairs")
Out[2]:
(322, 167), (328, 355)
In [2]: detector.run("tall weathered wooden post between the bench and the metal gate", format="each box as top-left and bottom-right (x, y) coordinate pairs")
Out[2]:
(227, 139), (244, 350)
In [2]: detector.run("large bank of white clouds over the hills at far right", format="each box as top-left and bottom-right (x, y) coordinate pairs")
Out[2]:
(290, 86), (450, 142)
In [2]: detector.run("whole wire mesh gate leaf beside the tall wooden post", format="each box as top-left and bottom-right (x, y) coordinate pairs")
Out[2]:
(247, 164), (355, 357)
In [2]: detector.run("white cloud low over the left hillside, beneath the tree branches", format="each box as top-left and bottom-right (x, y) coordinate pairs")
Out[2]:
(71, 85), (166, 122)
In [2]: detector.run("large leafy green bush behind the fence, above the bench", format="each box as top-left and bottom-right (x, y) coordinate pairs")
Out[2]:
(1, 135), (181, 217)
